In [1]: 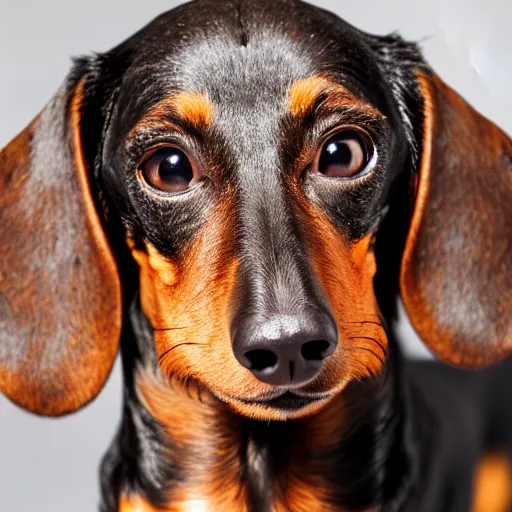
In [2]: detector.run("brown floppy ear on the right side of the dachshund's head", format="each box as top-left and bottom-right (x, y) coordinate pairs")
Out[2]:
(400, 73), (512, 367)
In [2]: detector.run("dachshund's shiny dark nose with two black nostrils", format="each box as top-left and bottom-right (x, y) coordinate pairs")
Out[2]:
(233, 311), (338, 386)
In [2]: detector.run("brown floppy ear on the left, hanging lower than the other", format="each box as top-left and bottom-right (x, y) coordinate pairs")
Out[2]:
(0, 73), (121, 416)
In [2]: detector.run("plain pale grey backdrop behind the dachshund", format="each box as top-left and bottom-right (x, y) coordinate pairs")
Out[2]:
(0, 0), (512, 512)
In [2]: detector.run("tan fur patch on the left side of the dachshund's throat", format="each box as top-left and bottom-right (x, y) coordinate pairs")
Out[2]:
(137, 374), (247, 512)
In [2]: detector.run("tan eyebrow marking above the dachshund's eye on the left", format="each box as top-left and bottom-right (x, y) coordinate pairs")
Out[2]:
(132, 92), (214, 133)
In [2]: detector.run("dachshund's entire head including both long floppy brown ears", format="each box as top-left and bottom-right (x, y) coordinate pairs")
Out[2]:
(0, 0), (512, 419)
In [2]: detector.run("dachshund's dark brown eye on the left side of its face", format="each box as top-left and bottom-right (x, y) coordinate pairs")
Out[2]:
(139, 147), (198, 192)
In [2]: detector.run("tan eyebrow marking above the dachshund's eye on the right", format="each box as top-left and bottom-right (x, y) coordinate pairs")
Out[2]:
(288, 75), (384, 118)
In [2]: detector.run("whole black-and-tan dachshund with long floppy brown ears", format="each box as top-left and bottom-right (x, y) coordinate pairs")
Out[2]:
(0, 0), (512, 512)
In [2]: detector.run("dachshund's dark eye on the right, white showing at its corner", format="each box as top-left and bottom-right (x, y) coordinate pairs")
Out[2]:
(314, 130), (371, 178)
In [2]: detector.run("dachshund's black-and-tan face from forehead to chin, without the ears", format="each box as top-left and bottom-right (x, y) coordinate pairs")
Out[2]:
(103, 4), (407, 418)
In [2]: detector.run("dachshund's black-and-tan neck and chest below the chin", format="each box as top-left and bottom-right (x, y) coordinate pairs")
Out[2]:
(107, 302), (407, 512)
